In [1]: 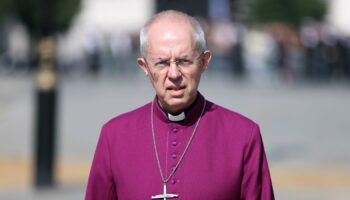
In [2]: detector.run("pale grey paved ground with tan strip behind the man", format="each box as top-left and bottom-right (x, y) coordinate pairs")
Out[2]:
(0, 73), (350, 200)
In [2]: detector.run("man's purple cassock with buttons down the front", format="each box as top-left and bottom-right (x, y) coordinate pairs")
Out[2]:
(85, 94), (274, 200)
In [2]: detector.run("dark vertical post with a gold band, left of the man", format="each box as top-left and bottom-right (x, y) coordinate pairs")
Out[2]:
(35, 38), (57, 187)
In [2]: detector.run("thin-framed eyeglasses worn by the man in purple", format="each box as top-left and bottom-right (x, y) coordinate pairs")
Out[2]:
(144, 52), (204, 70)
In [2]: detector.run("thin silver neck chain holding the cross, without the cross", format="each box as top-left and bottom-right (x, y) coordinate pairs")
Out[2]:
(151, 99), (207, 186)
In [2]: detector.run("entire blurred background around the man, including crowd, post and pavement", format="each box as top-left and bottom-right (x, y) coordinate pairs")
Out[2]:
(0, 0), (350, 200)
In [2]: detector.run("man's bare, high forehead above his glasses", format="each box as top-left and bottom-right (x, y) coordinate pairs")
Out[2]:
(147, 20), (195, 54)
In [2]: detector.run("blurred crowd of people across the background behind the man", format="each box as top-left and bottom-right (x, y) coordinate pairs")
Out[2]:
(0, 18), (350, 82)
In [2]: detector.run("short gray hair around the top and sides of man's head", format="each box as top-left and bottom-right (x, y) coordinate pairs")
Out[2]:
(140, 10), (207, 57)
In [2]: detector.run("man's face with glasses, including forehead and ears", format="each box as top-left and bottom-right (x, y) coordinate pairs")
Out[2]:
(138, 21), (211, 113)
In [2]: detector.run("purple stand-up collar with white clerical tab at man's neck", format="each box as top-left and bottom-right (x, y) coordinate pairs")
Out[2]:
(153, 92), (205, 124)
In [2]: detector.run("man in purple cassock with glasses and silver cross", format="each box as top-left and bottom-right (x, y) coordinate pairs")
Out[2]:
(86, 11), (274, 200)
